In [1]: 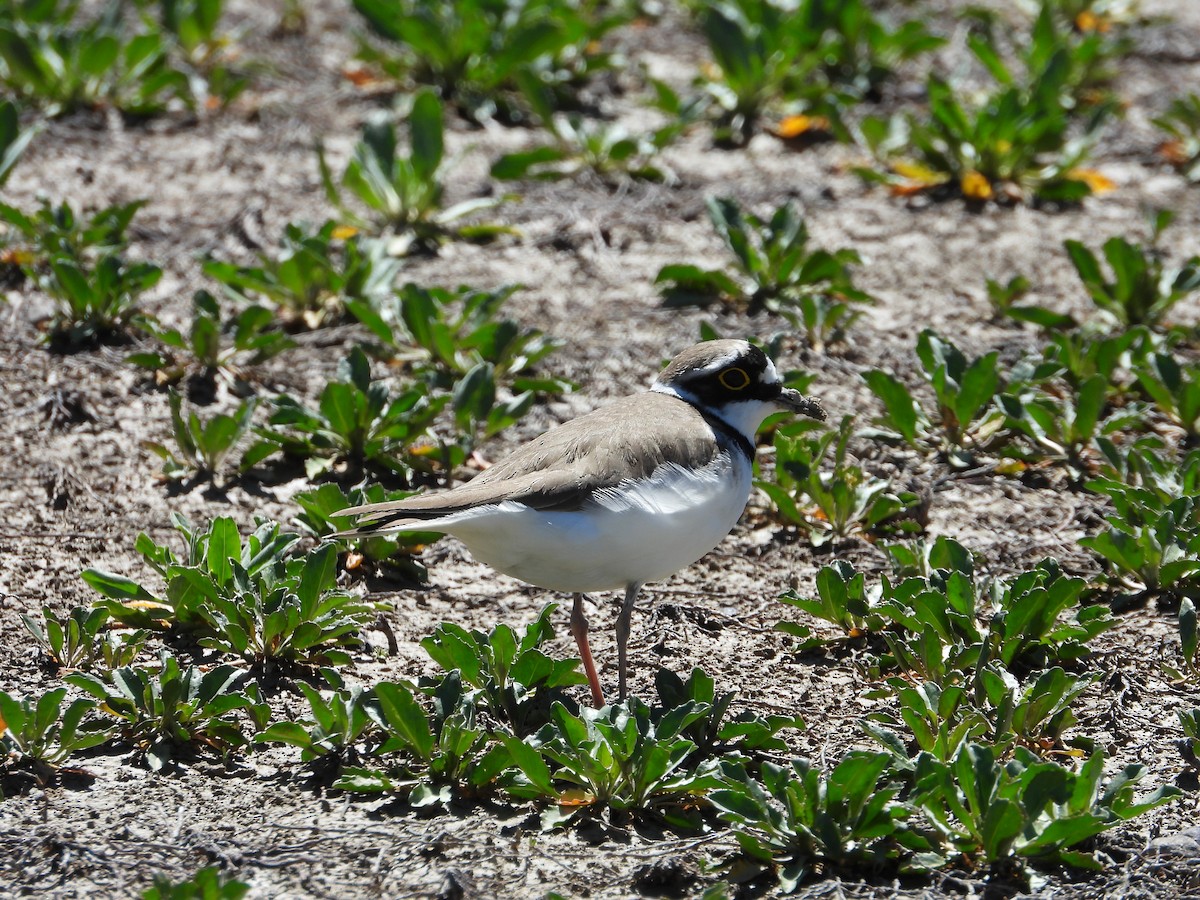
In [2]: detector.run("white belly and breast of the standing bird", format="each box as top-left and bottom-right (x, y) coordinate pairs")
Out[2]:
(422, 454), (750, 593)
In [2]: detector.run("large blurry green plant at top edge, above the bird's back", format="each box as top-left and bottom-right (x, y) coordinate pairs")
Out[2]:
(354, 0), (629, 121)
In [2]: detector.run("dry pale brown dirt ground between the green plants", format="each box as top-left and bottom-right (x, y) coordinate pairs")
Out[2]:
(0, 0), (1200, 900)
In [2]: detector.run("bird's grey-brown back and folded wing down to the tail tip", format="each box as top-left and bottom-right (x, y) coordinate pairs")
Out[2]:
(337, 391), (719, 528)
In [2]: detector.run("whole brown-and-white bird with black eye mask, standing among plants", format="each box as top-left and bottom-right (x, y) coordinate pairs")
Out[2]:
(335, 340), (826, 708)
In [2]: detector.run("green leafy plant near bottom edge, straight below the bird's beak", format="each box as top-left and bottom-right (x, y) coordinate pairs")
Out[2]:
(708, 751), (907, 893)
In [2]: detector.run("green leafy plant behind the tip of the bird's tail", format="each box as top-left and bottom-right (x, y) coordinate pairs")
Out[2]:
(292, 484), (442, 582)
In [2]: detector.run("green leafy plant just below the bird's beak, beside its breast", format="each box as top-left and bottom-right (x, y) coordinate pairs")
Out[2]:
(755, 415), (920, 546)
